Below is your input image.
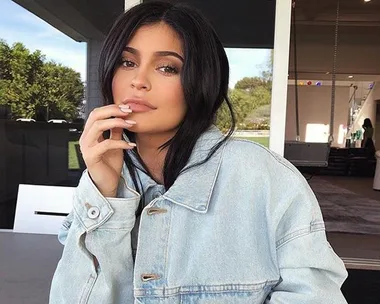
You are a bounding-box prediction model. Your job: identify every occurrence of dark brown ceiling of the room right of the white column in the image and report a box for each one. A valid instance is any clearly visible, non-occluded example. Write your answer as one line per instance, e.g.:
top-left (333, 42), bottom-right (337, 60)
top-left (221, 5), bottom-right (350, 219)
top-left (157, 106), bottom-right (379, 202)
top-left (289, 0), bottom-right (380, 81)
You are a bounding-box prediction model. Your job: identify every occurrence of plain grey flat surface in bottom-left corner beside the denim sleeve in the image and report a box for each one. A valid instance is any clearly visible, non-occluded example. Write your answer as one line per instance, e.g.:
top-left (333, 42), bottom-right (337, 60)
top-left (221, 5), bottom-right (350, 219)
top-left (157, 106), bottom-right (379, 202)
top-left (0, 232), bottom-right (63, 304)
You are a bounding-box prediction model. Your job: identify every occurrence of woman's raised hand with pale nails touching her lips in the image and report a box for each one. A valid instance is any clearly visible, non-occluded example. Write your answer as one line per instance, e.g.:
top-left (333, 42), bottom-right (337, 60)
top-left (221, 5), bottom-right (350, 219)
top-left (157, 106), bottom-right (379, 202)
top-left (79, 104), bottom-right (136, 197)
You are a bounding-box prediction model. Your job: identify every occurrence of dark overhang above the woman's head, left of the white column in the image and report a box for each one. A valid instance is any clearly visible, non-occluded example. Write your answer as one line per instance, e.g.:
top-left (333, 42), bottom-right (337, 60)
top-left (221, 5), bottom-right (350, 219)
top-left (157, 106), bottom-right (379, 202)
top-left (13, 0), bottom-right (276, 48)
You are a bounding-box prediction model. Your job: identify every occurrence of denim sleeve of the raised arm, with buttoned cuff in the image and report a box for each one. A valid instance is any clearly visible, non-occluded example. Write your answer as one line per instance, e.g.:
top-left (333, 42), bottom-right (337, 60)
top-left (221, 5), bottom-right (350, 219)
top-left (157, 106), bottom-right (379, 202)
top-left (49, 171), bottom-right (140, 304)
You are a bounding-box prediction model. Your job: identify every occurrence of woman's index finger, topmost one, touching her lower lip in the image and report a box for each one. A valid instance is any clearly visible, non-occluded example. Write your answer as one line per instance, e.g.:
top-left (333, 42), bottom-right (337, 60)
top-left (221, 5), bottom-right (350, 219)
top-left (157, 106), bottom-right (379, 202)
top-left (83, 104), bottom-right (132, 140)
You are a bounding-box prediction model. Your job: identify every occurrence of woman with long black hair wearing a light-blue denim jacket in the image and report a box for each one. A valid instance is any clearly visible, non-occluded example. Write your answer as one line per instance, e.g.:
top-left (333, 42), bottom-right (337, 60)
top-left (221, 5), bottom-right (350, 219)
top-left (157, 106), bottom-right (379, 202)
top-left (50, 2), bottom-right (346, 304)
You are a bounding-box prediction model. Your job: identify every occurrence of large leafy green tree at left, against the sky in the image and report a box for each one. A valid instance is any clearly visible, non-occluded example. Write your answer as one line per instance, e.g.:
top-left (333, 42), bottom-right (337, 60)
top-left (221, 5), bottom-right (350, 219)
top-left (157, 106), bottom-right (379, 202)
top-left (0, 40), bottom-right (84, 120)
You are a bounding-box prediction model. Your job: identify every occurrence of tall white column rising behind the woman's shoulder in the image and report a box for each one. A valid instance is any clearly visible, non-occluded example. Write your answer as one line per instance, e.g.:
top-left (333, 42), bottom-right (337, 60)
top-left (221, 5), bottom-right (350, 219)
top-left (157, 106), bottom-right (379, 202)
top-left (269, 0), bottom-right (292, 155)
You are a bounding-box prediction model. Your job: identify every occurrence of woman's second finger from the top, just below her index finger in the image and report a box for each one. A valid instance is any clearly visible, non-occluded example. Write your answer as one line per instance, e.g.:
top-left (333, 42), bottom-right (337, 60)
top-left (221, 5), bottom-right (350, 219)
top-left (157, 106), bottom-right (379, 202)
top-left (81, 118), bottom-right (136, 147)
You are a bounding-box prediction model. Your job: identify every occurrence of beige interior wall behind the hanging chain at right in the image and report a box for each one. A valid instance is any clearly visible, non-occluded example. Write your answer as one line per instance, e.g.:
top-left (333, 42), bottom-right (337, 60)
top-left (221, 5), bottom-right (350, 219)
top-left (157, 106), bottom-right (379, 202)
top-left (285, 85), bottom-right (350, 146)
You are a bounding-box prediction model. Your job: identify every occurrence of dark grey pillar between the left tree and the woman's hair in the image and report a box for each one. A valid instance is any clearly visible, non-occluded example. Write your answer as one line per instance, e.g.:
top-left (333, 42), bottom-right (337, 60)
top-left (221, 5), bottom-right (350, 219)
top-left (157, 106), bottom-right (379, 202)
top-left (85, 39), bottom-right (103, 118)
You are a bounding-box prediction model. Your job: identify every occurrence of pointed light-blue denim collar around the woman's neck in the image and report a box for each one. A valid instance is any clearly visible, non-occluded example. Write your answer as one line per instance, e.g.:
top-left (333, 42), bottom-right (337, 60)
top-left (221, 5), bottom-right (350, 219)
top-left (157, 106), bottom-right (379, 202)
top-left (123, 126), bottom-right (225, 213)
